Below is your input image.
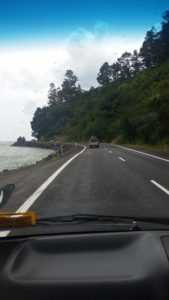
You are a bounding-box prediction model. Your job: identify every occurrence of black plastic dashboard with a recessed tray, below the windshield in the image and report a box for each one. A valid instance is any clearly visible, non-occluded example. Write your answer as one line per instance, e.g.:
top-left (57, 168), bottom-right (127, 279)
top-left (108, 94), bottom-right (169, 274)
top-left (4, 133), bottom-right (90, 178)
top-left (0, 231), bottom-right (169, 300)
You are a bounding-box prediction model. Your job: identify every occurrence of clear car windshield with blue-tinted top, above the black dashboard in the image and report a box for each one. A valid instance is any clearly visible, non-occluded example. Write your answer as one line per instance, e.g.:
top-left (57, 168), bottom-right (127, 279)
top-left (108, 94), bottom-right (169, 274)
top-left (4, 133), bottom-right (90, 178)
top-left (0, 0), bottom-right (169, 237)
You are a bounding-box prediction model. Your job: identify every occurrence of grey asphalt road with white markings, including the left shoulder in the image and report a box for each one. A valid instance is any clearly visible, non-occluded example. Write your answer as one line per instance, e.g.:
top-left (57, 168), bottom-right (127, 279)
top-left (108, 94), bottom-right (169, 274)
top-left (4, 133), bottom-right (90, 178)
top-left (2, 144), bottom-right (169, 224)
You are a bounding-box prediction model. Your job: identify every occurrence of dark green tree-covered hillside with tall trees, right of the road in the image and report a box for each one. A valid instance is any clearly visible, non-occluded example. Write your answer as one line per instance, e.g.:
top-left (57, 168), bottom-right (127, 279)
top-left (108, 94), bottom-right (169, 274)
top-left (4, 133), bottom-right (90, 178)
top-left (31, 11), bottom-right (169, 144)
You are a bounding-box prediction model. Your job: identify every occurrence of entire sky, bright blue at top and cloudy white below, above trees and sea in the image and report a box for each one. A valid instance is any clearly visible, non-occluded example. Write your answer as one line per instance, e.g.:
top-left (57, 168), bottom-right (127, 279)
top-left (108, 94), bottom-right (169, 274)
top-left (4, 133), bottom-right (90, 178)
top-left (0, 0), bottom-right (169, 141)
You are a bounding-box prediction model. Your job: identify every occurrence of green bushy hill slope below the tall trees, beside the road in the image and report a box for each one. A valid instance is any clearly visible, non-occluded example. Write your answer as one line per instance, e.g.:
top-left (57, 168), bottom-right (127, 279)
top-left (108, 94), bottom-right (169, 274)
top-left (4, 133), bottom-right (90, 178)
top-left (62, 62), bottom-right (169, 143)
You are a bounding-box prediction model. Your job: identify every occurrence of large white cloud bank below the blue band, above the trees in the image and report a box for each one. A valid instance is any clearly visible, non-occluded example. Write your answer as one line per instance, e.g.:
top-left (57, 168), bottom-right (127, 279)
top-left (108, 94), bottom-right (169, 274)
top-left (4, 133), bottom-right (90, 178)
top-left (0, 21), bottom-right (143, 140)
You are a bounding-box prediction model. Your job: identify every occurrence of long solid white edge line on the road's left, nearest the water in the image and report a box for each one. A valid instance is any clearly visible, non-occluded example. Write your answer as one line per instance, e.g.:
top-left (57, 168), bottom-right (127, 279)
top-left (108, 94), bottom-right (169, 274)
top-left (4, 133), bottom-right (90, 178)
top-left (0, 145), bottom-right (86, 237)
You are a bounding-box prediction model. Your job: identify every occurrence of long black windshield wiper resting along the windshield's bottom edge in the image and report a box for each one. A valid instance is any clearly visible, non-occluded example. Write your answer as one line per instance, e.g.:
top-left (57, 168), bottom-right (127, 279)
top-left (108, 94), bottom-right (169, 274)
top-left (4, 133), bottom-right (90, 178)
top-left (36, 214), bottom-right (137, 230)
